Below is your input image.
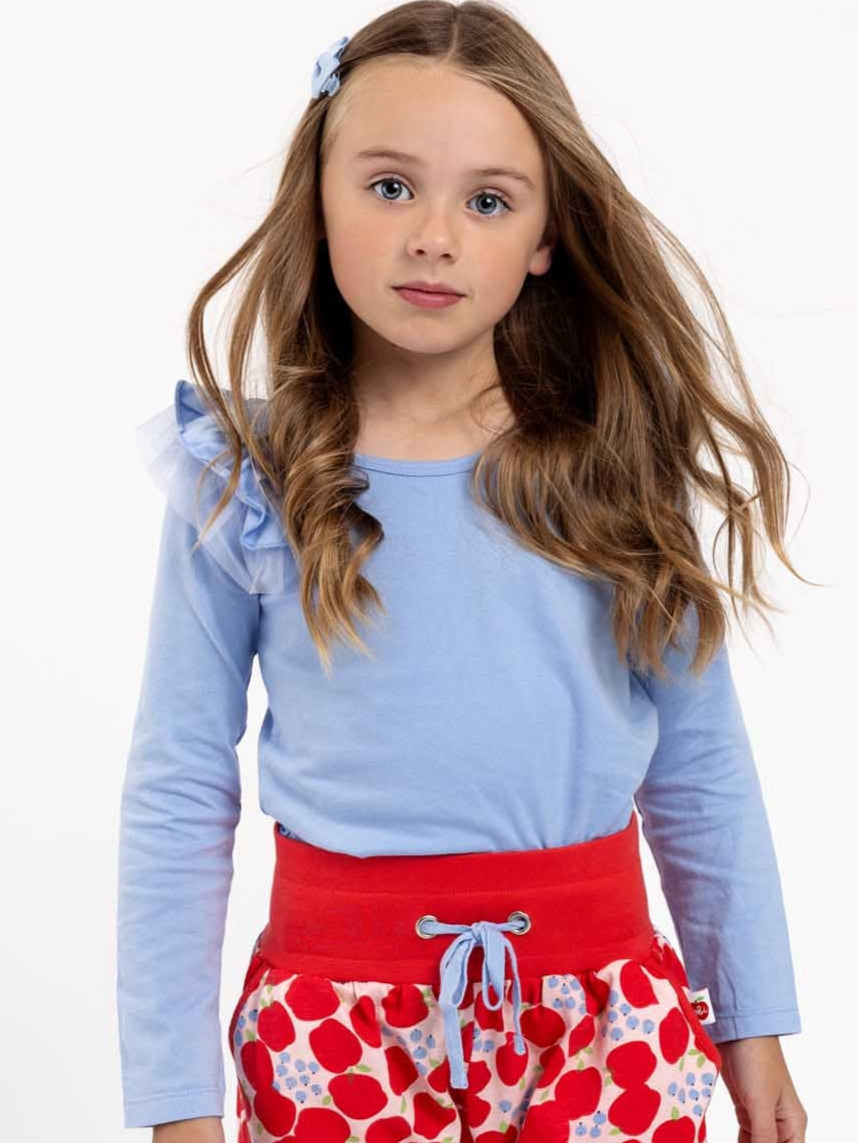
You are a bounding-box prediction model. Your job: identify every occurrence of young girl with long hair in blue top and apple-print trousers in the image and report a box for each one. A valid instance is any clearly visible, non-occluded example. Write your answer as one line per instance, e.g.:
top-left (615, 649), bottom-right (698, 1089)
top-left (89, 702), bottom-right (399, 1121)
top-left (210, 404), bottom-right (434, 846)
top-left (118, 0), bottom-right (807, 1143)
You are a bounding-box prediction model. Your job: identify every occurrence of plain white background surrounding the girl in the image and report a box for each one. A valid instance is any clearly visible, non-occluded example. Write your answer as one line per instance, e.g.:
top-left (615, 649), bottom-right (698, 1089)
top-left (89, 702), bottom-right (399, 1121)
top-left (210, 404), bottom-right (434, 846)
top-left (0, 0), bottom-right (858, 1143)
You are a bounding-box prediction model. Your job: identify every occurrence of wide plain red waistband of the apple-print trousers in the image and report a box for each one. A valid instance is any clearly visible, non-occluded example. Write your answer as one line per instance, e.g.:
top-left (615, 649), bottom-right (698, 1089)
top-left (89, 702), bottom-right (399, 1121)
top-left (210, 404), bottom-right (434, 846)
top-left (255, 810), bottom-right (653, 983)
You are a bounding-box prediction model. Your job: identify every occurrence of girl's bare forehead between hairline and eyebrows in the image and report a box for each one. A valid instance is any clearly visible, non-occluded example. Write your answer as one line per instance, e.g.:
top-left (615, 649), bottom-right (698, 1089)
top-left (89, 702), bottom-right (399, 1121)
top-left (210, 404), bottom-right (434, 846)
top-left (329, 56), bottom-right (540, 182)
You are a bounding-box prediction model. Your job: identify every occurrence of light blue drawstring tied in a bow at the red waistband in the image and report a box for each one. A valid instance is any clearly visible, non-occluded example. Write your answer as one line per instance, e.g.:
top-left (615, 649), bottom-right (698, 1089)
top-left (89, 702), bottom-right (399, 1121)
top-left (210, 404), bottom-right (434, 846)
top-left (420, 919), bottom-right (527, 1088)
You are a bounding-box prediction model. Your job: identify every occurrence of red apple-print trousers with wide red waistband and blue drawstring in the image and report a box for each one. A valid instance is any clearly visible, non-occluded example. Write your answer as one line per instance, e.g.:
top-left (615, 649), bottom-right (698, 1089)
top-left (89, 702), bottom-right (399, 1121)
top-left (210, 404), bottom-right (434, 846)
top-left (228, 812), bottom-right (721, 1143)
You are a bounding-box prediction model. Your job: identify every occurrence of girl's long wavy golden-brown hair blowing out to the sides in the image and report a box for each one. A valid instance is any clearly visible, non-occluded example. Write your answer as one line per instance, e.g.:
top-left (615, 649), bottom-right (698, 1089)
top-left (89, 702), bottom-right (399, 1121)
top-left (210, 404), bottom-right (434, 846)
top-left (181, 0), bottom-right (808, 677)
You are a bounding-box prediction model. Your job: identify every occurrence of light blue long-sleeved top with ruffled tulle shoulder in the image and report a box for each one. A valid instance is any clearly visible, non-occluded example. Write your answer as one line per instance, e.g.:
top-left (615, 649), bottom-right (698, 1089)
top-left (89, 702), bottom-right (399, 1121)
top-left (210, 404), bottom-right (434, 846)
top-left (117, 381), bottom-right (801, 1127)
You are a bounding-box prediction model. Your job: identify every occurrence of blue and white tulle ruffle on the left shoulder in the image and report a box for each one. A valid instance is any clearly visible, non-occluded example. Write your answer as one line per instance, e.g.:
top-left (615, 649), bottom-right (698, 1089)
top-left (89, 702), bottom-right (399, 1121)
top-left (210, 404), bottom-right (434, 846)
top-left (135, 379), bottom-right (295, 593)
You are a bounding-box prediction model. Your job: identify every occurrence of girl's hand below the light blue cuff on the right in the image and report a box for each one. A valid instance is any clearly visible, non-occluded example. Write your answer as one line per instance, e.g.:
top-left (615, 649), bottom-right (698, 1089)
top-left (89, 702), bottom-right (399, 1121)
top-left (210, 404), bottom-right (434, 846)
top-left (717, 1036), bottom-right (808, 1143)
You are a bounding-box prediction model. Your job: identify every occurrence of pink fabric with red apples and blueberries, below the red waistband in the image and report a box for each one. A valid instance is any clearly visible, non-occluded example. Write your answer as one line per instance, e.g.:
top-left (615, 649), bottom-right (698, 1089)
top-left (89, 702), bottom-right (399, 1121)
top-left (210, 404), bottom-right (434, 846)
top-left (228, 929), bottom-right (721, 1143)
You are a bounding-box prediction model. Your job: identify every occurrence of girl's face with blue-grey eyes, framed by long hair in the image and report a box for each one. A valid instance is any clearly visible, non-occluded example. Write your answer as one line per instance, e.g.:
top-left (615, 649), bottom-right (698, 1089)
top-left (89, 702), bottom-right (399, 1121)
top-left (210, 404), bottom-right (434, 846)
top-left (321, 58), bottom-right (551, 353)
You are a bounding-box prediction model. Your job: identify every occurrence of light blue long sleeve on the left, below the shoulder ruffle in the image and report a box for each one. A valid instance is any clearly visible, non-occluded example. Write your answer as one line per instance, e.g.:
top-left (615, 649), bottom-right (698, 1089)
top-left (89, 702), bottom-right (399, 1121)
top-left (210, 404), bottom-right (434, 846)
top-left (117, 502), bottom-right (259, 1127)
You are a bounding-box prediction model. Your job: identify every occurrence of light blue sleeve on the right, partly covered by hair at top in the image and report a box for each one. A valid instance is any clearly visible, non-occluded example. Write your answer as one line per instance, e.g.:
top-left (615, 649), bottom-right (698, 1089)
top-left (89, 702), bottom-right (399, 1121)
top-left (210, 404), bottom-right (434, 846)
top-left (634, 608), bottom-right (802, 1042)
